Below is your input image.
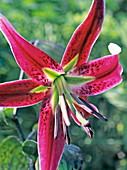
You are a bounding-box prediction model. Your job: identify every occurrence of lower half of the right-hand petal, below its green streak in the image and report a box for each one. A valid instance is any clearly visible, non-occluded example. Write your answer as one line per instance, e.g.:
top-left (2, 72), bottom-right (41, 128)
top-left (70, 57), bottom-right (122, 96)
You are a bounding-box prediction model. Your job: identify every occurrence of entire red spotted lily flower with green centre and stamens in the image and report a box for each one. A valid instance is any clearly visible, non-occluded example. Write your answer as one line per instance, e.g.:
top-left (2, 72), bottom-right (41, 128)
top-left (0, 0), bottom-right (122, 170)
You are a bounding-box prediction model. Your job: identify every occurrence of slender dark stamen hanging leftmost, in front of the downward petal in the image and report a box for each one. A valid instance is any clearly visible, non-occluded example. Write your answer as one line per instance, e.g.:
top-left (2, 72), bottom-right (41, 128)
top-left (54, 105), bottom-right (60, 139)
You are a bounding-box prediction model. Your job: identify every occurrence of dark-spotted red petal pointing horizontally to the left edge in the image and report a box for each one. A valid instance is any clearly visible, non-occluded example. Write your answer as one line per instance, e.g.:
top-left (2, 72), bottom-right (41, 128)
top-left (0, 79), bottom-right (45, 107)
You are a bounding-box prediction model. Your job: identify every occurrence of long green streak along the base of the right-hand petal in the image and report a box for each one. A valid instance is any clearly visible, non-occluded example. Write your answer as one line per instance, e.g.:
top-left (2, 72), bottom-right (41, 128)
top-left (65, 76), bottom-right (95, 85)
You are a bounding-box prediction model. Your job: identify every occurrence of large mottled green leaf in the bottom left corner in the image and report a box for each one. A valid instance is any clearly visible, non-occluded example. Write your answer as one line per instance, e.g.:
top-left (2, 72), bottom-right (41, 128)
top-left (0, 136), bottom-right (29, 170)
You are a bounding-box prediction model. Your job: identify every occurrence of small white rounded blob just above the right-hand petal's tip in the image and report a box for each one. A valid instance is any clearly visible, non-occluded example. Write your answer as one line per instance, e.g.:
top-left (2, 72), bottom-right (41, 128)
top-left (108, 43), bottom-right (121, 55)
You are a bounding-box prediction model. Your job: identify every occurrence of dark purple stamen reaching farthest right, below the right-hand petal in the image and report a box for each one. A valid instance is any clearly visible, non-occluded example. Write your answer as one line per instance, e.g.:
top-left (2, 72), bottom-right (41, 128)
top-left (70, 93), bottom-right (108, 121)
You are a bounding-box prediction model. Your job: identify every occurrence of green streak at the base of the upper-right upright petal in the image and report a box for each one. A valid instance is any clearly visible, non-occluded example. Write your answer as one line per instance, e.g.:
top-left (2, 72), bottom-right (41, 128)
top-left (63, 54), bottom-right (79, 73)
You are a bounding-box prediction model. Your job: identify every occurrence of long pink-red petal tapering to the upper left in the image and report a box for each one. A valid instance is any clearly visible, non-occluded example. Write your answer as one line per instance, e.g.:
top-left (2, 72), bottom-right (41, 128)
top-left (0, 14), bottom-right (63, 86)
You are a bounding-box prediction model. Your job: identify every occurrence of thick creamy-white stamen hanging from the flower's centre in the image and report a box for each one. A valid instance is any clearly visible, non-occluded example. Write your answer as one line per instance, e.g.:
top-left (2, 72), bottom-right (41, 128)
top-left (59, 94), bottom-right (71, 126)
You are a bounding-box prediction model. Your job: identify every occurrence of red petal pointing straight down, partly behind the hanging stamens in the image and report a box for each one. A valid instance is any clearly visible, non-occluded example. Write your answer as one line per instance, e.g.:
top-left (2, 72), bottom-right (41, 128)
top-left (38, 89), bottom-right (65, 170)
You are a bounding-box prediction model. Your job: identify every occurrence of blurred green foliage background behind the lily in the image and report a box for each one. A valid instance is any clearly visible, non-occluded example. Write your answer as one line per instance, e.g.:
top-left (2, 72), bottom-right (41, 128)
top-left (0, 0), bottom-right (127, 170)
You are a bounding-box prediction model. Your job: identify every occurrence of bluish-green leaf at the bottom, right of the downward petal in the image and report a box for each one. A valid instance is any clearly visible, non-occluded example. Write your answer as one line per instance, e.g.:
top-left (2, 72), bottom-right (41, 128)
top-left (58, 145), bottom-right (84, 170)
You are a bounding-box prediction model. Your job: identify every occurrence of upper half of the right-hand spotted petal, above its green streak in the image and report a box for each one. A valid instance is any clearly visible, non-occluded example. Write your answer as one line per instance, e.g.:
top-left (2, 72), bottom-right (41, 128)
top-left (69, 55), bottom-right (119, 78)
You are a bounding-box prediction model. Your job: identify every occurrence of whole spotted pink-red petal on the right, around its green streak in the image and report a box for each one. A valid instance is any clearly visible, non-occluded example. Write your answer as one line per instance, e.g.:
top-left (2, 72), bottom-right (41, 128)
top-left (70, 55), bottom-right (122, 96)
